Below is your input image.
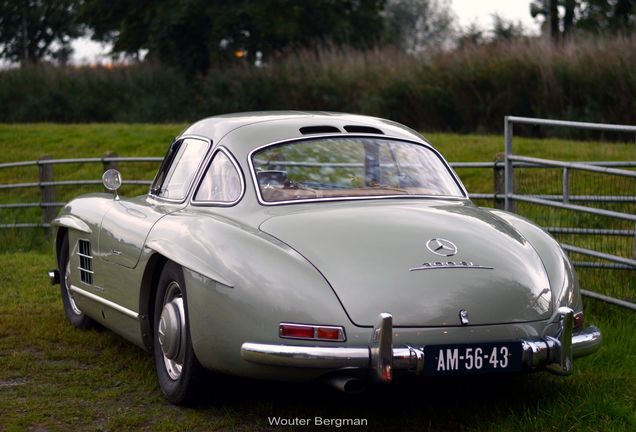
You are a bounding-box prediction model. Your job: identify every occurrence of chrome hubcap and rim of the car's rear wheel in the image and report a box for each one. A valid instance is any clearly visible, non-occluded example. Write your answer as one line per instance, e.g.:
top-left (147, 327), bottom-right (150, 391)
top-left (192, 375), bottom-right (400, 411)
top-left (157, 282), bottom-right (186, 380)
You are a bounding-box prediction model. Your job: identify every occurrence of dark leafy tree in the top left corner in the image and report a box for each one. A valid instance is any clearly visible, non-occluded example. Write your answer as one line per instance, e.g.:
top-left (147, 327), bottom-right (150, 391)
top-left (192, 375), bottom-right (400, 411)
top-left (0, 0), bottom-right (82, 65)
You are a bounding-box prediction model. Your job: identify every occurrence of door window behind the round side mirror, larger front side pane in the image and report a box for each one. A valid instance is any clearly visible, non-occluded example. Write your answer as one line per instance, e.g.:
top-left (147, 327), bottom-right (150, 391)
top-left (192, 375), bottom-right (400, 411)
top-left (153, 138), bottom-right (208, 200)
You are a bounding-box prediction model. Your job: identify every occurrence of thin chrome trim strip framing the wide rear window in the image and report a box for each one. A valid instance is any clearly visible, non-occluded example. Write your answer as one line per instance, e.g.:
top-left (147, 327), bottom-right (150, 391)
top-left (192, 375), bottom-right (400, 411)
top-left (247, 134), bottom-right (470, 206)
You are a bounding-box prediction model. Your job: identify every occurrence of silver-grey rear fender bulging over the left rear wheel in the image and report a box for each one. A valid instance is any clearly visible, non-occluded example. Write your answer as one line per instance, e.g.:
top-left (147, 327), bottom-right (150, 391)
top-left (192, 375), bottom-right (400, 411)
top-left (146, 212), bottom-right (353, 374)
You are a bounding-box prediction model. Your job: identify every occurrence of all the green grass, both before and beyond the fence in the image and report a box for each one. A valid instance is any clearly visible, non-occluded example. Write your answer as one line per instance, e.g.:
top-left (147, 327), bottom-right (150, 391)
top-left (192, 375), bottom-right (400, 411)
top-left (0, 125), bottom-right (636, 431)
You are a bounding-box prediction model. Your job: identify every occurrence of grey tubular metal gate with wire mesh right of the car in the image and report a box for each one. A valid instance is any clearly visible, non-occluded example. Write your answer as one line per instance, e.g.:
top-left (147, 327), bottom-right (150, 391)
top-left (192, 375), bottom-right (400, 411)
top-left (504, 117), bottom-right (636, 310)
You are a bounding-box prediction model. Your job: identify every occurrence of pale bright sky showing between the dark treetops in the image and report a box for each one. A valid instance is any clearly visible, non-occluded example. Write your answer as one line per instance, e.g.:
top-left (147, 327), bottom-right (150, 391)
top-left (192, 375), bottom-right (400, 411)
top-left (67, 0), bottom-right (540, 64)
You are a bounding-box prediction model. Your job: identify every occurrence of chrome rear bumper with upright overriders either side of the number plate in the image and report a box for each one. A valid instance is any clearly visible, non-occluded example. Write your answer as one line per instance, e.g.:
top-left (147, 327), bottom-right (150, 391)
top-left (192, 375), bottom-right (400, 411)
top-left (241, 307), bottom-right (601, 382)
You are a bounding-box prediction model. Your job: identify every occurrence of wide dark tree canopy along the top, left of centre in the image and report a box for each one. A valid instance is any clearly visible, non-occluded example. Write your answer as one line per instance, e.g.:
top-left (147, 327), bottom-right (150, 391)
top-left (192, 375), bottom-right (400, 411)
top-left (81, 0), bottom-right (384, 75)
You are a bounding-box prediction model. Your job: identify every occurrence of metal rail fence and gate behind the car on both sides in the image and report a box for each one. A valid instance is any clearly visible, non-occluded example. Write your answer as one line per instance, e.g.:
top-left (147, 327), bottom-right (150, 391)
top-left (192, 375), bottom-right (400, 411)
top-left (0, 121), bottom-right (636, 310)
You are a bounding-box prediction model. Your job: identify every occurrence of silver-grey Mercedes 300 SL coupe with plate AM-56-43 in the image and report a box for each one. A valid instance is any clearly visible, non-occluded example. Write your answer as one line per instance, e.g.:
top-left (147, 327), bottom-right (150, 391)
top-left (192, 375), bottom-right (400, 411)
top-left (50, 112), bottom-right (601, 403)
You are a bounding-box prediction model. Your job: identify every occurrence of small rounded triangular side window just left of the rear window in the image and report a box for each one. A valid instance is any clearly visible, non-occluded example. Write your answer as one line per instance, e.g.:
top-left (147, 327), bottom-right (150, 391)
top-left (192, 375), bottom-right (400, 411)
top-left (194, 151), bottom-right (242, 203)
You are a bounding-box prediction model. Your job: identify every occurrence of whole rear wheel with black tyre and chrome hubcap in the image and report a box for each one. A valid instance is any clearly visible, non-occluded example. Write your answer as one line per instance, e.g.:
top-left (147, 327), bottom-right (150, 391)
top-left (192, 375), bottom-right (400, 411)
top-left (153, 262), bottom-right (203, 405)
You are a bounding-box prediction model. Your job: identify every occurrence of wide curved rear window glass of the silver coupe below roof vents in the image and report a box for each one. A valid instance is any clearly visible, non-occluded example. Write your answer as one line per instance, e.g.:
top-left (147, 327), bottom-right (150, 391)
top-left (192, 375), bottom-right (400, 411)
top-left (251, 137), bottom-right (464, 203)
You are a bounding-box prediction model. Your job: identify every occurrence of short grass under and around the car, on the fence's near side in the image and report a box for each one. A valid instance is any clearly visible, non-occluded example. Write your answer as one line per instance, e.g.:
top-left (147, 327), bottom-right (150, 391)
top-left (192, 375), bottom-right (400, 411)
top-left (0, 253), bottom-right (636, 431)
